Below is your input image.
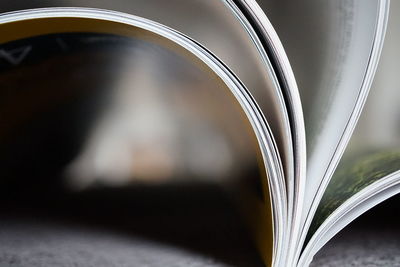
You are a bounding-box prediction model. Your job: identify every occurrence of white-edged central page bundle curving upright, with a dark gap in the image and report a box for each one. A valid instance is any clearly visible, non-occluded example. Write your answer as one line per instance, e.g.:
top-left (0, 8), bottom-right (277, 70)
top-left (227, 0), bottom-right (306, 265)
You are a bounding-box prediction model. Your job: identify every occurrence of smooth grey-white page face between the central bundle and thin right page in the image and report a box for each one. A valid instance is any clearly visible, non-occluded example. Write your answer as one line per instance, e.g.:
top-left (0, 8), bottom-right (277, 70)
top-left (259, 0), bottom-right (379, 216)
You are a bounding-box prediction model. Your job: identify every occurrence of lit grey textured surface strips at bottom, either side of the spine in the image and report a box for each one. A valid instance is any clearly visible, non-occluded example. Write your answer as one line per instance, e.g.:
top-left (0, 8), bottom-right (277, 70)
top-left (0, 219), bottom-right (400, 267)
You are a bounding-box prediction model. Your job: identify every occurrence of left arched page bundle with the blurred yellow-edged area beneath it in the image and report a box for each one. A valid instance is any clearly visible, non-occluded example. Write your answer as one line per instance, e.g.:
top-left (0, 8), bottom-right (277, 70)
top-left (0, 9), bottom-right (283, 263)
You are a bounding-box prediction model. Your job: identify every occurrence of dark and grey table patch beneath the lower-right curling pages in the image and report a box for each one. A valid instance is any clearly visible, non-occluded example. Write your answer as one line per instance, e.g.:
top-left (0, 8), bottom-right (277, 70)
top-left (311, 196), bottom-right (400, 267)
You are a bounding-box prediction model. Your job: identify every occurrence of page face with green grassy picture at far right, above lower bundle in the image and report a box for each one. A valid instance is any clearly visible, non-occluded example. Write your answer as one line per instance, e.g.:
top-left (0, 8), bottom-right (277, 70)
top-left (309, 3), bottom-right (400, 237)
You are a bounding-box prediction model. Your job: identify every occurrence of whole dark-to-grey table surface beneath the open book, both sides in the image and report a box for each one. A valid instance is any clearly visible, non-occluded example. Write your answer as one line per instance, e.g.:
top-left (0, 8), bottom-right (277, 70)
top-left (0, 185), bottom-right (400, 267)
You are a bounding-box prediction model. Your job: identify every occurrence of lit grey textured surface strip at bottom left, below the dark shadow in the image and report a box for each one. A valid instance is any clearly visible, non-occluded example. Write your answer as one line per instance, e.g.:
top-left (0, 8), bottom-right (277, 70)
top-left (0, 221), bottom-right (228, 267)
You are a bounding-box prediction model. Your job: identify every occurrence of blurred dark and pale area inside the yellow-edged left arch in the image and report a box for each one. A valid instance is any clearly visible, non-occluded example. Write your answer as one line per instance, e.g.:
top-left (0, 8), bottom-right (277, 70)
top-left (0, 33), bottom-right (257, 190)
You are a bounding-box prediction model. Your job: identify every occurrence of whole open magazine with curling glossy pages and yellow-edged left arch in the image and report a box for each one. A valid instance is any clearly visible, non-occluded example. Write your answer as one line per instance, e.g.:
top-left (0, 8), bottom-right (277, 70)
top-left (0, 0), bottom-right (400, 266)
